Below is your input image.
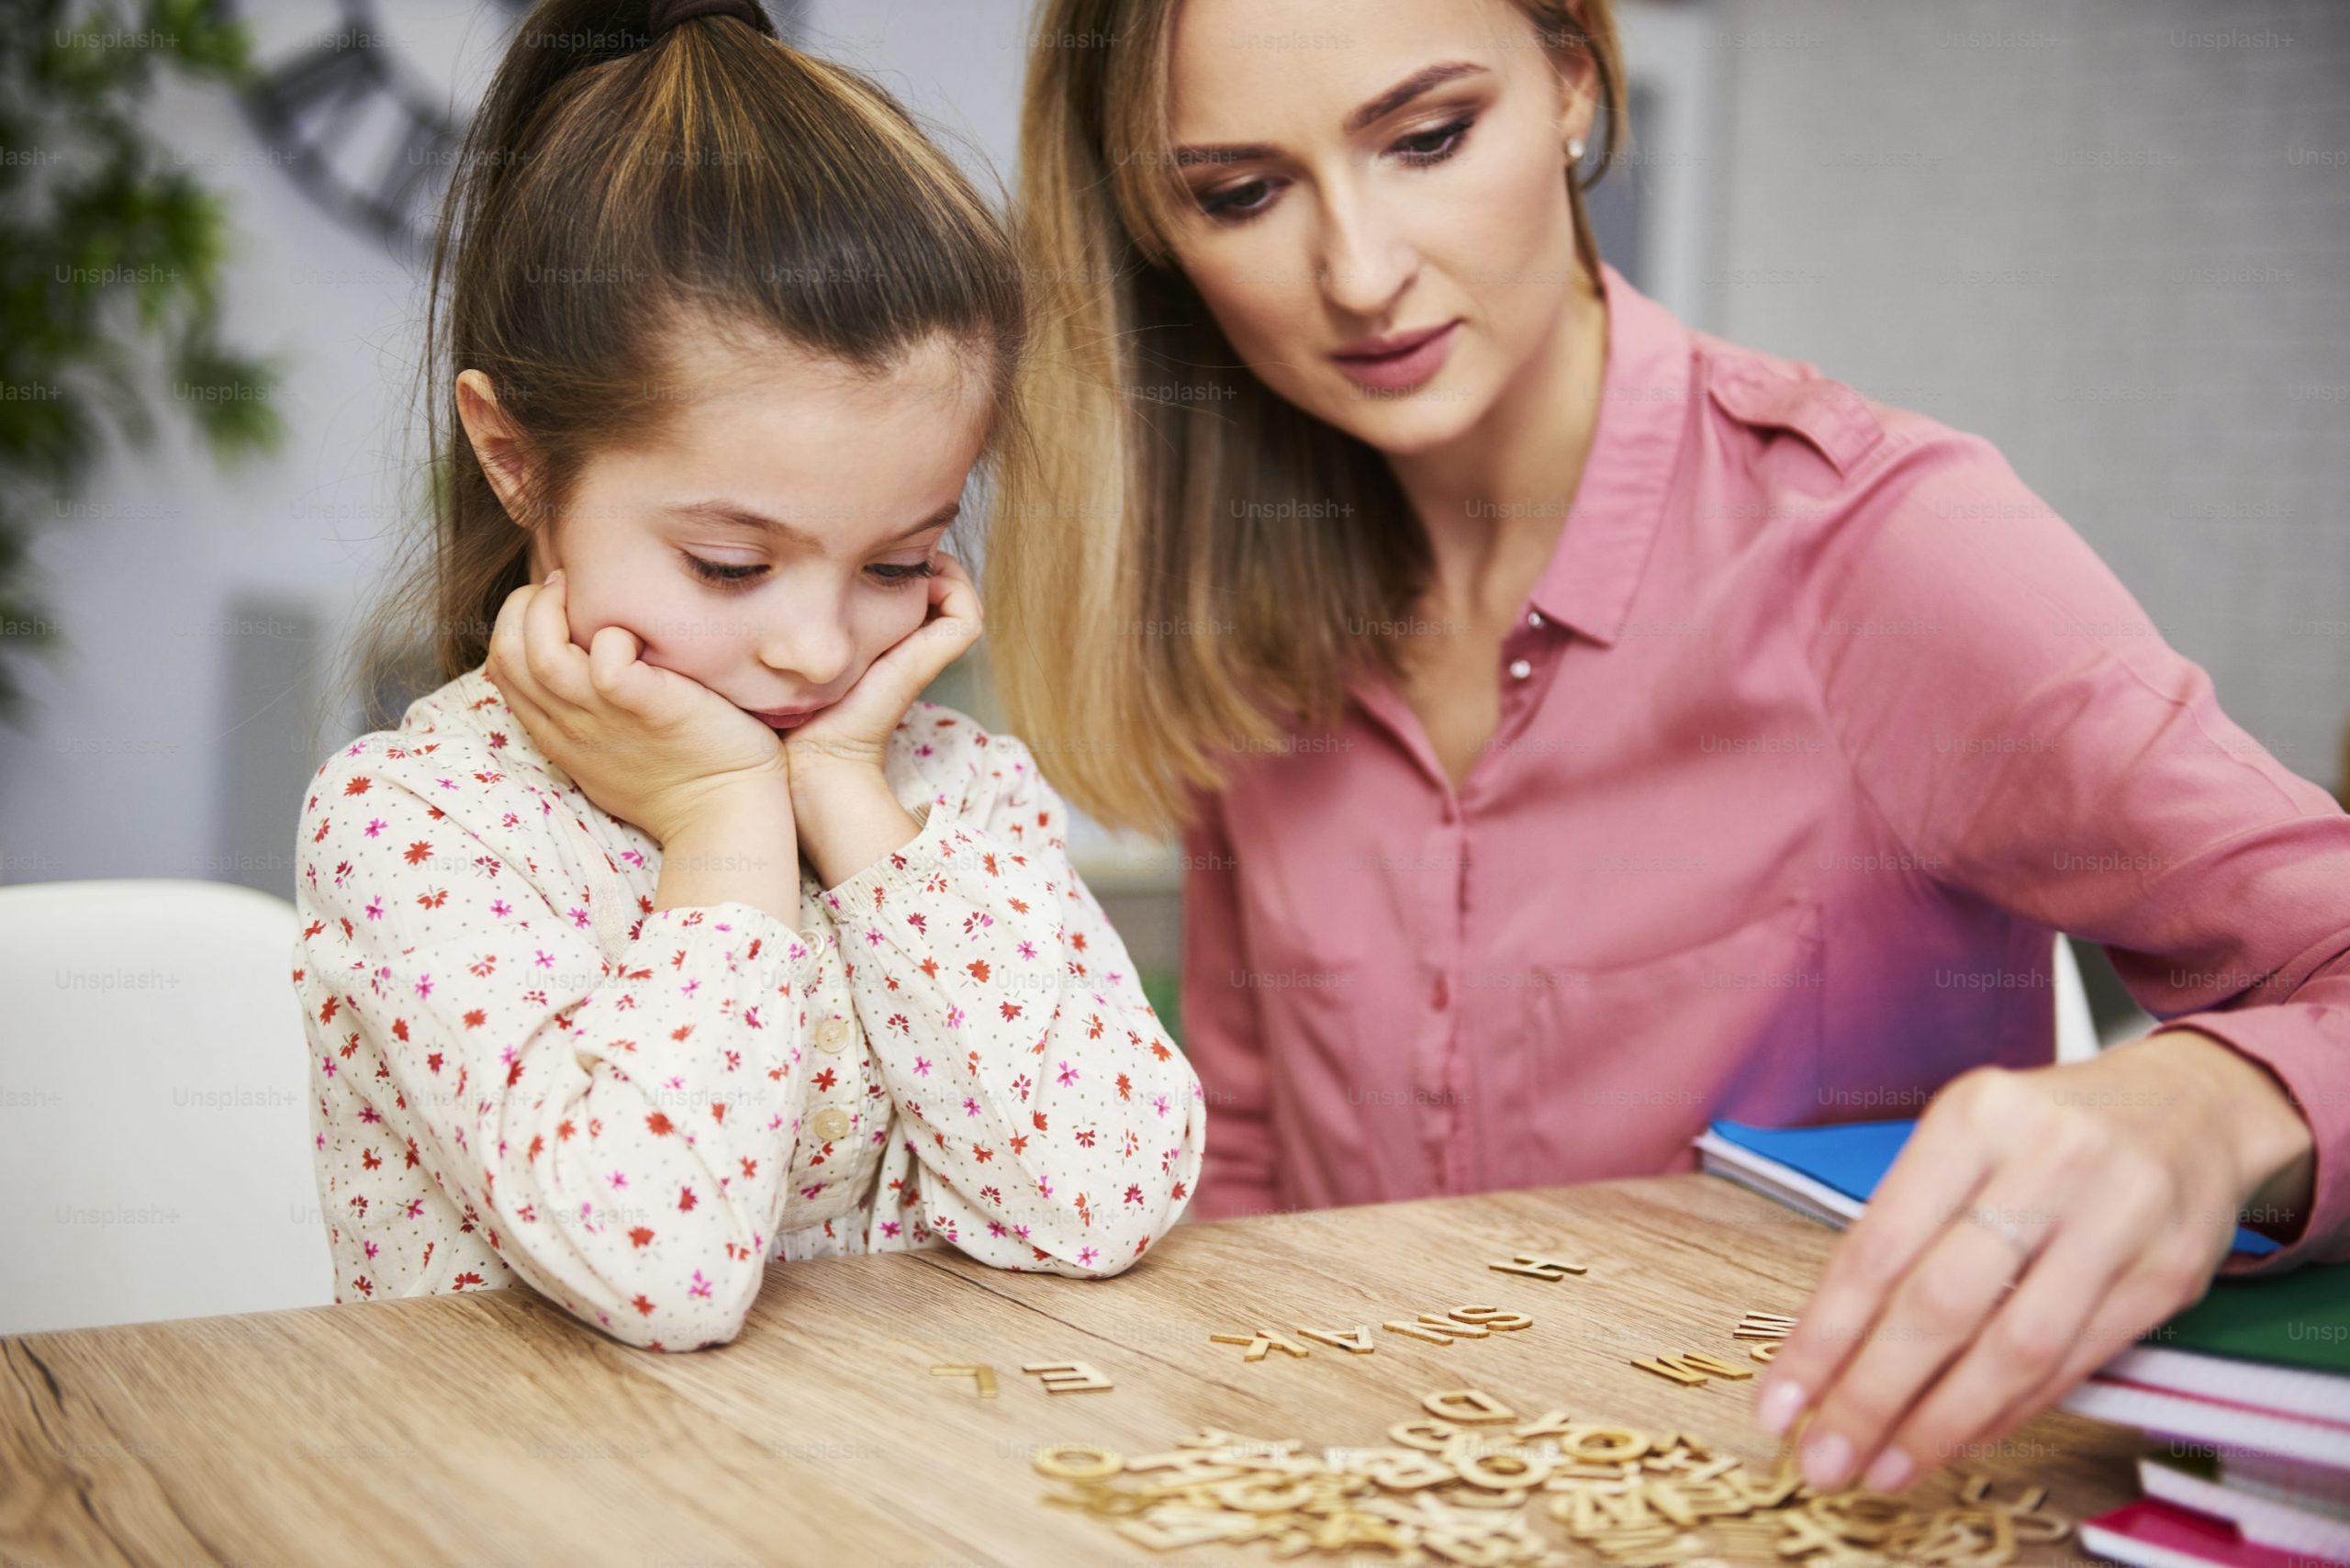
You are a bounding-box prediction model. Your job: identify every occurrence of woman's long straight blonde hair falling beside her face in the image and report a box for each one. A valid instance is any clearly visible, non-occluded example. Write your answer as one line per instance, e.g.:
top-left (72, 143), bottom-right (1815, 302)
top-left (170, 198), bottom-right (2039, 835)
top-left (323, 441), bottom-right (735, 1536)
top-left (987, 0), bottom-right (1624, 832)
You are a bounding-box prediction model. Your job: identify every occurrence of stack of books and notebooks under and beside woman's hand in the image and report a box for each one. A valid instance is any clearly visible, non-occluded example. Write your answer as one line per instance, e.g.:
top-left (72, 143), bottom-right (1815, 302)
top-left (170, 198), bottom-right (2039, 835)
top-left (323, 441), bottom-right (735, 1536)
top-left (1696, 1121), bottom-right (2350, 1568)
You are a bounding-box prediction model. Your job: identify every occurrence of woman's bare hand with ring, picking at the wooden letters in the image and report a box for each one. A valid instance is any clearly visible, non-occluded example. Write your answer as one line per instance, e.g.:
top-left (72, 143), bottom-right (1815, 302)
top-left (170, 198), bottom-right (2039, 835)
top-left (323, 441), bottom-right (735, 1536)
top-left (1755, 1030), bottom-right (2312, 1490)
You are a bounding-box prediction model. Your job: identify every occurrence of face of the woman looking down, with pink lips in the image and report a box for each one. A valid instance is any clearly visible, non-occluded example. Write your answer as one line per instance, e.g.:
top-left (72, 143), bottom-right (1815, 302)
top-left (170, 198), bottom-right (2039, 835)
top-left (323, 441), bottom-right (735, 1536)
top-left (1170, 0), bottom-right (1591, 456)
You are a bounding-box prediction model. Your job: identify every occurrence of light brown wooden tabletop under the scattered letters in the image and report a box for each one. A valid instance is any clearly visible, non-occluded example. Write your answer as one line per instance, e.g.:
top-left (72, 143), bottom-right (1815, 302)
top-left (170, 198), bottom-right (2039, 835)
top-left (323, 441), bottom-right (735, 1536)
top-left (0, 1175), bottom-right (2145, 1568)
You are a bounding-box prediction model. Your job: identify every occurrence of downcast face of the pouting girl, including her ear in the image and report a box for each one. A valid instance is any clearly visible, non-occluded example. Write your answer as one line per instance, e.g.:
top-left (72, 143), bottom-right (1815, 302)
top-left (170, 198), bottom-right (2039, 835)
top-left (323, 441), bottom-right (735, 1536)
top-left (458, 331), bottom-right (991, 729)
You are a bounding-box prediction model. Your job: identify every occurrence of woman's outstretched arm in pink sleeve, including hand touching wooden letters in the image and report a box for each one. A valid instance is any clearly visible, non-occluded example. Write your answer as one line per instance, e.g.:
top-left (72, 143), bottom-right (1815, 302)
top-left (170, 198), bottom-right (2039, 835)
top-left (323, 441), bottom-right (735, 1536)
top-left (1760, 416), bottom-right (2350, 1485)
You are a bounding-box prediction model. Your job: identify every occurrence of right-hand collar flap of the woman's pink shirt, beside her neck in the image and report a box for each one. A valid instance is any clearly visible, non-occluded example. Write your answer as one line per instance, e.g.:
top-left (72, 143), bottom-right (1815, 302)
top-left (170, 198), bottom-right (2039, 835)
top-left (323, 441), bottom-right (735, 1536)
top-left (1528, 261), bottom-right (1695, 644)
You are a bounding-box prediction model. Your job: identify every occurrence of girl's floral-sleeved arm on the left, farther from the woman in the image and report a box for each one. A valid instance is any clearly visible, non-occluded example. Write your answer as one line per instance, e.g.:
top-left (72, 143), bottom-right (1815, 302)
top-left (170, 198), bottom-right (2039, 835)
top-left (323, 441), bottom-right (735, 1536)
top-left (297, 741), bottom-right (815, 1350)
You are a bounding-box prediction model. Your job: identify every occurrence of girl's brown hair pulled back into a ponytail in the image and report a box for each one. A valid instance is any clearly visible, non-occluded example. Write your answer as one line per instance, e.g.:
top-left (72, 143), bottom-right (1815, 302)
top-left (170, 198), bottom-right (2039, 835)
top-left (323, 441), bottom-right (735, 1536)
top-left (329, 0), bottom-right (1027, 724)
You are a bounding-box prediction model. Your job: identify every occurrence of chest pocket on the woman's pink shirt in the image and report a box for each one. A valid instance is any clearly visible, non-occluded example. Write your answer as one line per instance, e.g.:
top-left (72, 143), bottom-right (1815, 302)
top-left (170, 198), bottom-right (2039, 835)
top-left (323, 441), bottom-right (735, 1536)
top-left (1481, 898), bottom-right (1826, 1187)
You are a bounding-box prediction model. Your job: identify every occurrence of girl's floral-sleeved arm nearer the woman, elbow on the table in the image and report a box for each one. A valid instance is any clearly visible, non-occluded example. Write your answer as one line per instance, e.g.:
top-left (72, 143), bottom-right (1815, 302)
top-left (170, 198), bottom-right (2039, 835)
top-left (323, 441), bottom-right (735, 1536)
top-left (801, 705), bottom-right (1205, 1274)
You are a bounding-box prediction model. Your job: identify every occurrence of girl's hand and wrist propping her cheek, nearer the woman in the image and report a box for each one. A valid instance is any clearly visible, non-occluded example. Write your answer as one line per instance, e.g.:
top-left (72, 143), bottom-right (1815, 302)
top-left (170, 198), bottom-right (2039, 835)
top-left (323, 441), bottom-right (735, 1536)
top-left (782, 553), bottom-right (980, 889)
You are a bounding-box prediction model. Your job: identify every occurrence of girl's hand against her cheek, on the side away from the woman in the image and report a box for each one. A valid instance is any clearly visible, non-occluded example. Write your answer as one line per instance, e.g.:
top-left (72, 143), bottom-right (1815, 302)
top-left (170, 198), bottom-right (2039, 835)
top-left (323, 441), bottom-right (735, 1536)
top-left (487, 571), bottom-right (789, 844)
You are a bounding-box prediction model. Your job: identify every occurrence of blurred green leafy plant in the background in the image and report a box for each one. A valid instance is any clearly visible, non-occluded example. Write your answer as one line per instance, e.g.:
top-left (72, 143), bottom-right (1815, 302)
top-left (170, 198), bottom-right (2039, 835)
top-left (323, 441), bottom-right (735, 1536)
top-left (0, 0), bottom-right (282, 720)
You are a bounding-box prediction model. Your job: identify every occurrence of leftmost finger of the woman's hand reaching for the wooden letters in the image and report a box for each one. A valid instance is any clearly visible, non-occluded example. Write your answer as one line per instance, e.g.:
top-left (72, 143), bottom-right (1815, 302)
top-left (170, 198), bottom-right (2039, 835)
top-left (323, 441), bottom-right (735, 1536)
top-left (1755, 1074), bottom-right (2007, 1448)
